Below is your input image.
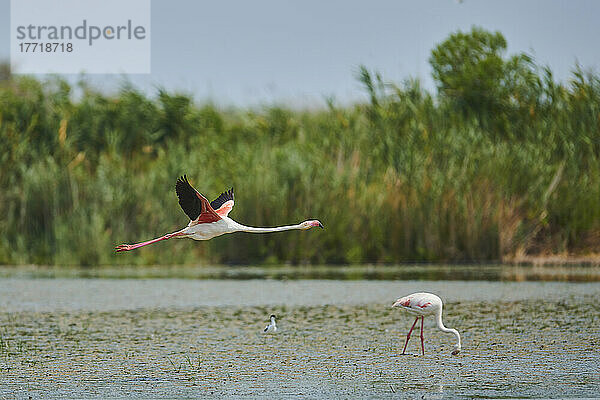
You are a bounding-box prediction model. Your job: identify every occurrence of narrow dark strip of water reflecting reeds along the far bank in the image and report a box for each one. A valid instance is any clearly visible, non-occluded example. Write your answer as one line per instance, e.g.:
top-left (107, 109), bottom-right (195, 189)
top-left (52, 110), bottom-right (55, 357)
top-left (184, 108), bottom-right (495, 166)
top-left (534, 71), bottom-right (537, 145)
top-left (0, 264), bottom-right (600, 282)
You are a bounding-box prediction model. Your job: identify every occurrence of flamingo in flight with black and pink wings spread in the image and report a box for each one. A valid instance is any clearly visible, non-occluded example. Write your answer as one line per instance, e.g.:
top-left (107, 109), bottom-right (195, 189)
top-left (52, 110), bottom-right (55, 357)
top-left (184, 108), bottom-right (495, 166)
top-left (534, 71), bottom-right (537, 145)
top-left (115, 175), bottom-right (323, 252)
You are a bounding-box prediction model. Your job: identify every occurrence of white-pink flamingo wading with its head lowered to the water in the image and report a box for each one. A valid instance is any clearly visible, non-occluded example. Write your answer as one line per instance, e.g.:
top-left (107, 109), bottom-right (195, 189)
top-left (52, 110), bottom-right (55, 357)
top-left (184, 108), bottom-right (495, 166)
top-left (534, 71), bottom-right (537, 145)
top-left (392, 293), bottom-right (461, 356)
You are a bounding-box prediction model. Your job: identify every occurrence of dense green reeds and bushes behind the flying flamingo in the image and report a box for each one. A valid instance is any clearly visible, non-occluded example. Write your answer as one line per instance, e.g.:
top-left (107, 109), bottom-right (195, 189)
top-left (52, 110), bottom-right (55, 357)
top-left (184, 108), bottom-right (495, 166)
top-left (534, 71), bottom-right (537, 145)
top-left (0, 28), bottom-right (600, 265)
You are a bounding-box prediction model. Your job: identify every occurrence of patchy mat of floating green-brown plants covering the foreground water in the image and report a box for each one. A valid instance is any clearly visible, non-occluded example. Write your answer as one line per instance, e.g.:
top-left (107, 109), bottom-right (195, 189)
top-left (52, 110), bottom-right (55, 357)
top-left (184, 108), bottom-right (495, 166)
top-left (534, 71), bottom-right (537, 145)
top-left (0, 282), bottom-right (600, 398)
